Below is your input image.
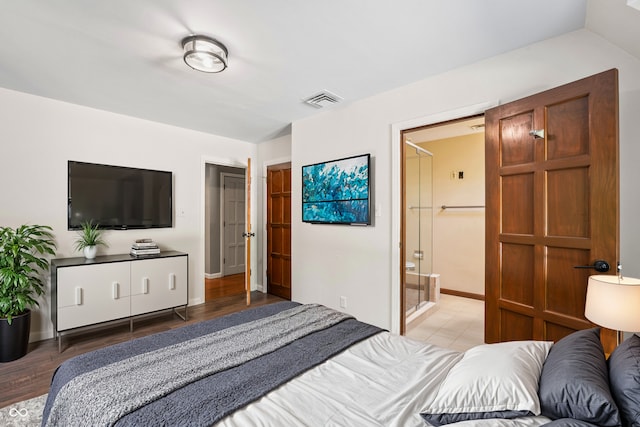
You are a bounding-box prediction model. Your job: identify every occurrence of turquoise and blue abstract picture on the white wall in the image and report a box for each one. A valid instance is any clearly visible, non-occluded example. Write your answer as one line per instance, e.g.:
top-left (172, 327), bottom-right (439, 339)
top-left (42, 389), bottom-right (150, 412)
top-left (302, 154), bottom-right (371, 225)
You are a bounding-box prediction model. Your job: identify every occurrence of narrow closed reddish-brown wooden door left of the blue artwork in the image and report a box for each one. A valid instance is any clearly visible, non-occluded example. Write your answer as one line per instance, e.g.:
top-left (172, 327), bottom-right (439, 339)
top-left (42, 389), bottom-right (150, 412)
top-left (267, 163), bottom-right (291, 299)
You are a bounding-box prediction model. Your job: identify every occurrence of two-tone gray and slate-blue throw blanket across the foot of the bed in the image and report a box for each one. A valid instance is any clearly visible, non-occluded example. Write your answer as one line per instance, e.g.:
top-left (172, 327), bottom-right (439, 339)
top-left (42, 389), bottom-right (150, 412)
top-left (43, 303), bottom-right (380, 426)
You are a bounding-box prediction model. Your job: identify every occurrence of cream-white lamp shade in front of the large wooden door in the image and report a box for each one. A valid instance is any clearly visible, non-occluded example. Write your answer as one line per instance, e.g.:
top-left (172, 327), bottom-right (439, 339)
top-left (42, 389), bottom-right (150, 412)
top-left (584, 275), bottom-right (640, 332)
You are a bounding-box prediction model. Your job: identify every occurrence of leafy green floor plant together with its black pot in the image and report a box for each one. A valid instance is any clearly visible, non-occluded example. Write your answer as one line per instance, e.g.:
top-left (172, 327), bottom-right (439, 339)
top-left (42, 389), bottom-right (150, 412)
top-left (0, 225), bottom-right (56, 362)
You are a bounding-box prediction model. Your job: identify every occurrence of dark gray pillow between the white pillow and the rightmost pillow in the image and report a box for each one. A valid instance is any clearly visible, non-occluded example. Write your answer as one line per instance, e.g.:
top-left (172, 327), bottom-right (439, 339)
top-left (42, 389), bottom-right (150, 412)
top-left (538, 328), bottom-right (620, 427)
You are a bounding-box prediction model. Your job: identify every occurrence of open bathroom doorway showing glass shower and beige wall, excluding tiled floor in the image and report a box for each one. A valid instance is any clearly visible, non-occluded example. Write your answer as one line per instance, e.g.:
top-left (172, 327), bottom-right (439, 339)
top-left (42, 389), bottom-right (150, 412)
top-left (400, 116), bottom-right (485, 332)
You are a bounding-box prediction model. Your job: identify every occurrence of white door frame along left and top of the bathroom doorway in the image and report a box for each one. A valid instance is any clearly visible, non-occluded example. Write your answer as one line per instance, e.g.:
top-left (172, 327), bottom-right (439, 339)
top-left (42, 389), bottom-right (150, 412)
top-left (391, 101), bottom-right (499, 334)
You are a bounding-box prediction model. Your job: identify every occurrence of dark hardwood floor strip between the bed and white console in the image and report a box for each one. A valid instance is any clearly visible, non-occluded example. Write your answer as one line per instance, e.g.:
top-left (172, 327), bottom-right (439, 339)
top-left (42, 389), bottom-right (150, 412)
top-left (0, 292), bottom-right (284, 408)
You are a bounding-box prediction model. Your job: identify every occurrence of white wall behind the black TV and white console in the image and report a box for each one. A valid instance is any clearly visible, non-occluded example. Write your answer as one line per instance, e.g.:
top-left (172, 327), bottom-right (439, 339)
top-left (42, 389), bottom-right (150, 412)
top-left (0, 89), bottom-right (257, 341)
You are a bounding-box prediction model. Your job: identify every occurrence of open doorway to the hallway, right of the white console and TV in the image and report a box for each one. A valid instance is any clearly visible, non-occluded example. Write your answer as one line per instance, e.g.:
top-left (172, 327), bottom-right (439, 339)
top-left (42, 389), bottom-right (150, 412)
top-left (204, 163), bottom-right (246, 301)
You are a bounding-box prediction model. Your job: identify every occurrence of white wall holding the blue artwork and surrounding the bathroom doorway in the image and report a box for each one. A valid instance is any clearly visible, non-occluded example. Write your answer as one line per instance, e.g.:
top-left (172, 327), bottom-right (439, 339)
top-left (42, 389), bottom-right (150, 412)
top-left (291, 30), bottom-right (640, 331)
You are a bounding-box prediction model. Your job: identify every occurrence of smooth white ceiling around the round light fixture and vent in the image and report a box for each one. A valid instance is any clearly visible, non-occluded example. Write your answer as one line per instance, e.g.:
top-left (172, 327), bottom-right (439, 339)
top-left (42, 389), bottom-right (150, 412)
top-left (0, 0), bottom-right (640, 142)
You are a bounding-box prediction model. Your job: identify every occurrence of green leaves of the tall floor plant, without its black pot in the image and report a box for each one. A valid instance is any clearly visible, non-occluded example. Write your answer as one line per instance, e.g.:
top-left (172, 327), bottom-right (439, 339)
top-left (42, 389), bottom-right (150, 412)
top-left (0, 225), bottom-right (56, 324)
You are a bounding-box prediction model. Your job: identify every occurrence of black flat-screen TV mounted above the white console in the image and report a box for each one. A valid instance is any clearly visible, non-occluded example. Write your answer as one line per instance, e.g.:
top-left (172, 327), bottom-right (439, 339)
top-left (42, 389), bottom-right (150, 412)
top-left (68, 161), bottom-right (173, 230)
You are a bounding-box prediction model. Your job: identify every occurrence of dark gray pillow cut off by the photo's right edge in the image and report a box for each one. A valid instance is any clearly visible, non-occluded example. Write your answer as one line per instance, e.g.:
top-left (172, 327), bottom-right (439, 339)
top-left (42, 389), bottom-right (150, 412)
top-left (608, 335), bottom-right (640, 427)
